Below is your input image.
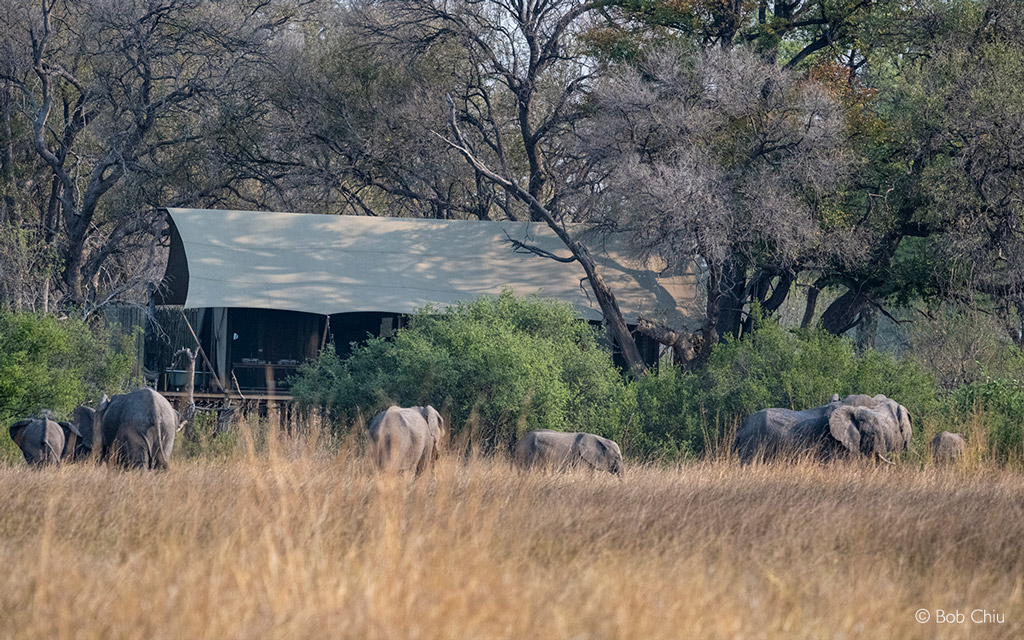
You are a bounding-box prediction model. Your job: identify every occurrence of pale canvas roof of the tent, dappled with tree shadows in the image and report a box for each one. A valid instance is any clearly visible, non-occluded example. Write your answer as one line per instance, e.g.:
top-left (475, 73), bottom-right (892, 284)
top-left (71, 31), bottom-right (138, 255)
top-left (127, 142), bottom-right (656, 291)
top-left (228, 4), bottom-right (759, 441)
top-left (159, 209), bottom-right (696, 326)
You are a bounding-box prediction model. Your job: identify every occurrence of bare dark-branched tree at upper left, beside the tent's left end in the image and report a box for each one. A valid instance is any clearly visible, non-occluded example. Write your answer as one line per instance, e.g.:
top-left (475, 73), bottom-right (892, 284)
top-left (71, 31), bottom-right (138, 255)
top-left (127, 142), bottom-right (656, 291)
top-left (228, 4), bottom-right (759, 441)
top-left (0, 0), bottom-right (303, 307)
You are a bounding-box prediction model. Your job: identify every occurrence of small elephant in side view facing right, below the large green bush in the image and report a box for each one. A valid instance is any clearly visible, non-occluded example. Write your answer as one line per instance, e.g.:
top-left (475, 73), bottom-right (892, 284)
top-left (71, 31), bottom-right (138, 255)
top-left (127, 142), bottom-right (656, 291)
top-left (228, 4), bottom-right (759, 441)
top-left (513, 429), bottom-right (623, 475)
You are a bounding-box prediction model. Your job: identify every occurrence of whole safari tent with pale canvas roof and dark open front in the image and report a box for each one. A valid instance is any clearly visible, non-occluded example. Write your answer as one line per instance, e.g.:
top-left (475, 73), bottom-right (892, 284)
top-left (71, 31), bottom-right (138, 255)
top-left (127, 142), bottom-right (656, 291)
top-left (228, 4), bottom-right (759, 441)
top-left (143, 209), bottom-right (698, 403)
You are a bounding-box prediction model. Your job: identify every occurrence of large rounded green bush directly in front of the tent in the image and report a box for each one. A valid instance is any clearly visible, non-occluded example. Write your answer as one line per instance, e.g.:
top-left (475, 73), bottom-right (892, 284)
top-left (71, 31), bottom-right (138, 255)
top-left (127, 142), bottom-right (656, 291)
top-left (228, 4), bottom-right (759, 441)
top-left (293, 292), bottom-right (634, 449)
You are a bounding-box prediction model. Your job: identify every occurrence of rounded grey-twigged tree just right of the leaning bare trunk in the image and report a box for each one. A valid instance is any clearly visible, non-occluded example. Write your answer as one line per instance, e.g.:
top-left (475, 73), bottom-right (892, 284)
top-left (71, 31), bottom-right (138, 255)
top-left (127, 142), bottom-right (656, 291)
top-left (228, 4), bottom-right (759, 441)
top-left (585, 49), bottom-right (847, 364)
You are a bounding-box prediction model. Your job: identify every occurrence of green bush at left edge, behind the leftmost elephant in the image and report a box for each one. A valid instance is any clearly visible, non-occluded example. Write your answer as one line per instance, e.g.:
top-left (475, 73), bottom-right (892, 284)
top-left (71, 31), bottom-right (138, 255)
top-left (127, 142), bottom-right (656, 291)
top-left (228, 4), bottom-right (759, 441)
top-left (0, 311), bottom-right (134, 458)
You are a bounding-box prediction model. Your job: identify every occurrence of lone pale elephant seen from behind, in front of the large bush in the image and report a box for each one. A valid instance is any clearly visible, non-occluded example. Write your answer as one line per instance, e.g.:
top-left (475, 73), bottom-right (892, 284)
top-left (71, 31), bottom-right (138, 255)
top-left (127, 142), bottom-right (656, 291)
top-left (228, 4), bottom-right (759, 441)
top-left (370, 406), bottom-right (445, 475)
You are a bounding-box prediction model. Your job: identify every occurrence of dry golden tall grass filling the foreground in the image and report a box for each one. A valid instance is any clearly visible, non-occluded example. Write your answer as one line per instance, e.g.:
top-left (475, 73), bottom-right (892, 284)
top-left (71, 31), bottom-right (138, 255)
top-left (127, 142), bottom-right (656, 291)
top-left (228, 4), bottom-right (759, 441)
top-left (0, 430), bottom-right (1024, 639)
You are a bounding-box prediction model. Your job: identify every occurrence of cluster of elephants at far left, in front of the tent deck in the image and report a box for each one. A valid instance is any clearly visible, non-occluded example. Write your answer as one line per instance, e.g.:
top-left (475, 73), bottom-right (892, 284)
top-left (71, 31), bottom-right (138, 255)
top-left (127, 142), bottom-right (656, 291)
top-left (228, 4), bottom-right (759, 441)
top-left (10, 388), bottom-right (187, 469)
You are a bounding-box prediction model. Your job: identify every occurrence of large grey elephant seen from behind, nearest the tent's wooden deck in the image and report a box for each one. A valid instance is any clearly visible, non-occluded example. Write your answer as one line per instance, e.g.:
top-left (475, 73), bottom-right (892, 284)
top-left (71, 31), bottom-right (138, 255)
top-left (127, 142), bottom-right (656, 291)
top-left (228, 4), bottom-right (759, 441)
top-left (96, 388), bottom-right (187, 470)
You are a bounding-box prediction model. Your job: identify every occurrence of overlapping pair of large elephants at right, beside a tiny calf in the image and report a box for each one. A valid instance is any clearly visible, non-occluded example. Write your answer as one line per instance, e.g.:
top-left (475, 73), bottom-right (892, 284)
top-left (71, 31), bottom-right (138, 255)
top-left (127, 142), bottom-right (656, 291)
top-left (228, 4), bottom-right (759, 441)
top-left (733, 394), bottom-right (913, 463)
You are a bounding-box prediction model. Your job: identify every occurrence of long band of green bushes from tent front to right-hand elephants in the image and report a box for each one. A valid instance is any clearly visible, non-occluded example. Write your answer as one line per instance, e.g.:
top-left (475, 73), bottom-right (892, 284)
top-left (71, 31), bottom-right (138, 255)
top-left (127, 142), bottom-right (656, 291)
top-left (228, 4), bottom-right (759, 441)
top-left (293, 293), bottom-right (938, 460)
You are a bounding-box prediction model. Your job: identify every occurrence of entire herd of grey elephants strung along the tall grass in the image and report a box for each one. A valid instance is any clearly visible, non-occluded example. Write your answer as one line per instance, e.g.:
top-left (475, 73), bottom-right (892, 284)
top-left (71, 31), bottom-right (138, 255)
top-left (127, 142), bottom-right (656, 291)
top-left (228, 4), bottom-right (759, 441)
top-left (10, 388), bottom-right (966, 475)
